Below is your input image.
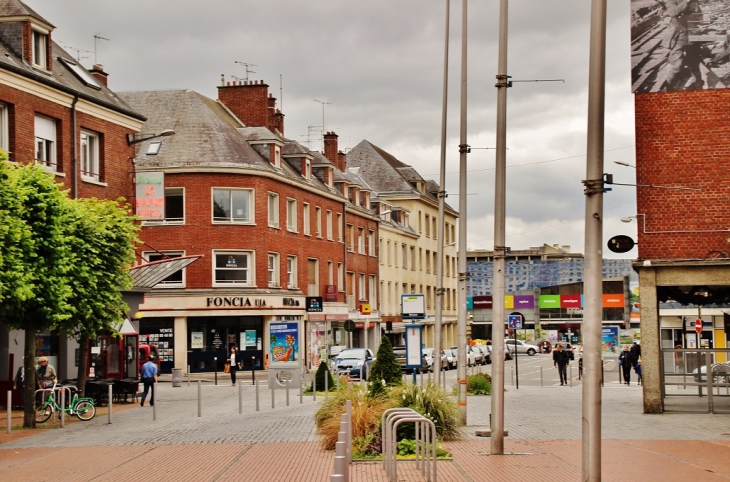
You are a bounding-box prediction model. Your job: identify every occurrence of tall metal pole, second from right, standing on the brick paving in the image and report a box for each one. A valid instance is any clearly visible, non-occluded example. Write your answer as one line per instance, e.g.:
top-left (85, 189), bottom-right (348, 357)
top-left (490, 0), bottom-right (509, 455)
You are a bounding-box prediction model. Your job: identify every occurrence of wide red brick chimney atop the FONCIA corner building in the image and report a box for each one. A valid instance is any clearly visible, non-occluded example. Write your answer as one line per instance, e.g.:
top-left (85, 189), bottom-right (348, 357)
top-left (218, 80), bottom-right (272, 130)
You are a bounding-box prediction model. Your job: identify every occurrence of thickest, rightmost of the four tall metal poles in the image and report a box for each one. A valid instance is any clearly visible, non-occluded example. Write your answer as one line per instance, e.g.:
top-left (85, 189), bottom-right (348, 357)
top-left (582, 0), bottom-right (607, 482)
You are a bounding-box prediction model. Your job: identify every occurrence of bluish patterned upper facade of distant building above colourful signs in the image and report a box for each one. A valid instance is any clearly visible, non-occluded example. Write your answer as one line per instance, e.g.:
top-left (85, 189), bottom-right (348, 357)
top-left (466, 258), bottom-right (636, 296)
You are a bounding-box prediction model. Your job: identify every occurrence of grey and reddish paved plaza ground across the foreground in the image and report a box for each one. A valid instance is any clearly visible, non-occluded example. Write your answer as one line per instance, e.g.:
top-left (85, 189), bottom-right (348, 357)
top-left (0, 374), bottom-right (730, 482)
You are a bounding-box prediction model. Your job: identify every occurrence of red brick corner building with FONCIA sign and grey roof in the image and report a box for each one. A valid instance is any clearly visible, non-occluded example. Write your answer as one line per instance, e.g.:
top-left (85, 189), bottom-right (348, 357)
top-left (120, 81), bottom-right (379, 372)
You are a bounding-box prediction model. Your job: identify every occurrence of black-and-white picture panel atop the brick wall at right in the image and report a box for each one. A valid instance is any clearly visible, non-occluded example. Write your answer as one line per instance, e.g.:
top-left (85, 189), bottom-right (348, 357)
top-left (631, 0), bottom-right (730, 93)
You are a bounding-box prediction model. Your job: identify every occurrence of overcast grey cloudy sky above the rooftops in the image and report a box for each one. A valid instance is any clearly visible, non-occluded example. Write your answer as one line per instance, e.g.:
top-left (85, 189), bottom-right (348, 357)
top-left (31, 0), bottom-right (636, 257)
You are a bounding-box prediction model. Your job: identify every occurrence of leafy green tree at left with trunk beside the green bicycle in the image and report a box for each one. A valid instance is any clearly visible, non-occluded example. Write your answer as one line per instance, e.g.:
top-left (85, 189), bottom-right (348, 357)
top-left (0, 162), bottom-right (136, 427)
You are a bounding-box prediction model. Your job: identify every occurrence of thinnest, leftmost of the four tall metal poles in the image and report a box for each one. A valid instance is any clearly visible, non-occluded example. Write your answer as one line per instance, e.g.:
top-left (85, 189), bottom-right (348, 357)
top-left (433, 0), bottom-right (451, 396)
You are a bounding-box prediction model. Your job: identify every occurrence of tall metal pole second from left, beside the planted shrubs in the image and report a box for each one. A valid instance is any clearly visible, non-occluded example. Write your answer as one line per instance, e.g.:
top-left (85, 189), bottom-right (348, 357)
top-left (456, 0), bottom-right (469, 425)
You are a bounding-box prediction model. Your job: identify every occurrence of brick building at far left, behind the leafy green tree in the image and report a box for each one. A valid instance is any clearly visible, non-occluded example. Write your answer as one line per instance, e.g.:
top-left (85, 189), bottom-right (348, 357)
top-left (0, 0), bottom-right (144, 384)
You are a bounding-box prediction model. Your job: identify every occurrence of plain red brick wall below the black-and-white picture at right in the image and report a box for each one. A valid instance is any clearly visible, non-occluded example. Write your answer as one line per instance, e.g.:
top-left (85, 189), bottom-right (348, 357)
top-left (635, 89), bottom-right (730, 259)
